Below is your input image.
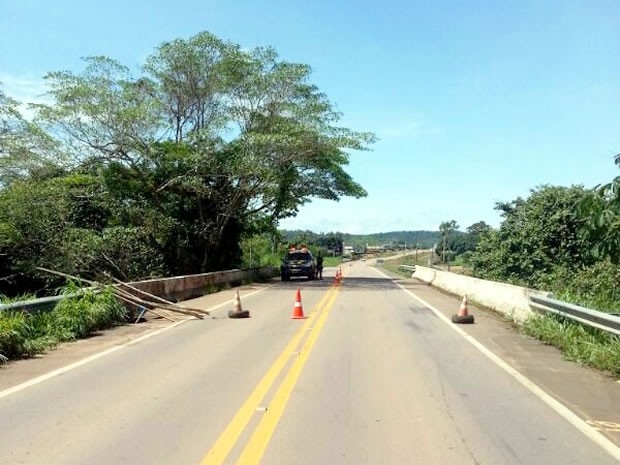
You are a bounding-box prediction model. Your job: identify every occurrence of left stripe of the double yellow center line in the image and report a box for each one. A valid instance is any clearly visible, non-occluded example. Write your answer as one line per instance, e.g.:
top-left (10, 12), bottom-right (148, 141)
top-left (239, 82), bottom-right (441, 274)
top-left (200, 288), bottom-right (335, 465)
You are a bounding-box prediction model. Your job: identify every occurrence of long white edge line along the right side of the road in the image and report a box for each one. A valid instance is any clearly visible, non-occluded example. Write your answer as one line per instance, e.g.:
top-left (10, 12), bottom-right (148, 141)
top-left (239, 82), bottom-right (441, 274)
top-left (374, 268), bottom-right (620, 460)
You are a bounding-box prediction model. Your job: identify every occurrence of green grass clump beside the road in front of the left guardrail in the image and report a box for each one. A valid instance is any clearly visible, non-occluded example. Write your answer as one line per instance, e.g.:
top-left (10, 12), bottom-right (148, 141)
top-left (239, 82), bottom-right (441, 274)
top-left (0, 285), bottom-right (127, 362)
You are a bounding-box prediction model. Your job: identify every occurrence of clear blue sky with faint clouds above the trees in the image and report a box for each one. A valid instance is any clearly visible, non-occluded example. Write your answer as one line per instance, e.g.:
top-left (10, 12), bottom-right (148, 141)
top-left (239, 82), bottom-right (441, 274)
top-left (0, 0), bottom-right (620, 233)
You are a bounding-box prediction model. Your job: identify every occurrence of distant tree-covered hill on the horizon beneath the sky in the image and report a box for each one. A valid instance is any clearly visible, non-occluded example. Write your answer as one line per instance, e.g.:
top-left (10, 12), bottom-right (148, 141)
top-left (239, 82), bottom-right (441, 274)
top-left (280, 230), bottom-right (439, 249)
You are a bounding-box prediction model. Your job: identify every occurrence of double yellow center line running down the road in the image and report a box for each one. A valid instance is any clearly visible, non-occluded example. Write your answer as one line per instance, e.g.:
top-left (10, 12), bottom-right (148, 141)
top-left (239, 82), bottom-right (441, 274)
top-left (200, 287), bottom-right (339, 465)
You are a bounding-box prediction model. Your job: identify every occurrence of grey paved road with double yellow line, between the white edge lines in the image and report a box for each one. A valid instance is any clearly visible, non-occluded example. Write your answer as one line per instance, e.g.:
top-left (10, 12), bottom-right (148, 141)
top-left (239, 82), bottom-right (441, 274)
top-left (0, 263), bottom-right (618, 465)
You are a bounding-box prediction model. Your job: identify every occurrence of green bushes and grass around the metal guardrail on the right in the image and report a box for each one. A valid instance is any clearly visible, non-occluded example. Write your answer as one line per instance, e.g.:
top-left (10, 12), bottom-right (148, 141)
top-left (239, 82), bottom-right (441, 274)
top-left (438, 165), bottom-right (620, 375)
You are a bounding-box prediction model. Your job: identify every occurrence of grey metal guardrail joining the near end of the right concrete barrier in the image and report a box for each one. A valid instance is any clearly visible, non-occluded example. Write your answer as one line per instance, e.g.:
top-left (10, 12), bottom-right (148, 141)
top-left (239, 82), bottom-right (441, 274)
top-left (530, 295), bottom-right (620, 336)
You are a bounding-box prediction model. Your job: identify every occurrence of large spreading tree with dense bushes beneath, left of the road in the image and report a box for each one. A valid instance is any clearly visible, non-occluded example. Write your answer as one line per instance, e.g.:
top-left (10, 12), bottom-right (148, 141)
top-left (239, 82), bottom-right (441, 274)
top-left (0, 32), bottom-right (375, 296)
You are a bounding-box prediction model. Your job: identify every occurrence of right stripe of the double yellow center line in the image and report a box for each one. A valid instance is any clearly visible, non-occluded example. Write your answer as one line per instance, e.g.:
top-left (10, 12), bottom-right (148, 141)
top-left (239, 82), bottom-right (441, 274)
top-left (237, 292), bottom-right (337, 465)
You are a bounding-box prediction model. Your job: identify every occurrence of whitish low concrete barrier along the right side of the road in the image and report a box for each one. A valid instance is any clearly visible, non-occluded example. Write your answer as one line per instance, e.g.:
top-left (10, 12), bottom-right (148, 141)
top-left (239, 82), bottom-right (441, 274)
top-left (411, 265), bottom-right (552, 324)
